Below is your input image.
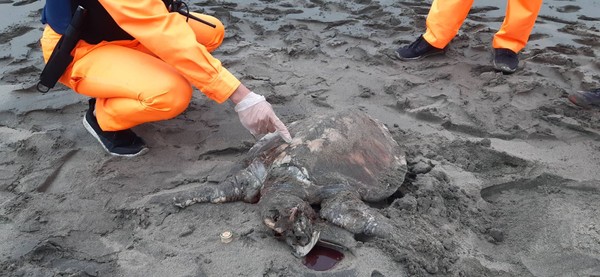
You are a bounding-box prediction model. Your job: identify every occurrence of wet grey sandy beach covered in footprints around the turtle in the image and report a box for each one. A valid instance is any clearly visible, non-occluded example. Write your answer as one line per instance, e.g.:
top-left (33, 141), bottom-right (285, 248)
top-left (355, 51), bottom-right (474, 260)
top-left (0, 0), bottom-right (600, 277)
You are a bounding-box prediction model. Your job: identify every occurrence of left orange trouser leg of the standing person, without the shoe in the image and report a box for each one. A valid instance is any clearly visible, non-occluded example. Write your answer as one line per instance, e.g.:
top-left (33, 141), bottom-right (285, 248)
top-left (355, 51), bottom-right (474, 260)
top-left (423, 0), bottom-right (473, 48)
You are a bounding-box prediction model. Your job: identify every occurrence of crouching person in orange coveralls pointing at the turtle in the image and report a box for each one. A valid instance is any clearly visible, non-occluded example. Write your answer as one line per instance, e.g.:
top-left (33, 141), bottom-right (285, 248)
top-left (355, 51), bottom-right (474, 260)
top-left (40, 0), bottom-right (291, 157)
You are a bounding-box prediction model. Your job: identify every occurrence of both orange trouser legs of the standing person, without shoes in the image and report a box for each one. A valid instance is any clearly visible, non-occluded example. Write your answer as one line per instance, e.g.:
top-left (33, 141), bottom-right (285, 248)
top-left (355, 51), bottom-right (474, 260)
top-left (423, 0), bottom-right (542, 53)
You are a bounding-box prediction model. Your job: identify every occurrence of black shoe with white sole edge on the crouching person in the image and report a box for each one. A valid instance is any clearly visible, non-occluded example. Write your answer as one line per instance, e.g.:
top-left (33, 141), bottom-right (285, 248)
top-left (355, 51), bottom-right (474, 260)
top-left (83, 98), bottom-right (148, 157)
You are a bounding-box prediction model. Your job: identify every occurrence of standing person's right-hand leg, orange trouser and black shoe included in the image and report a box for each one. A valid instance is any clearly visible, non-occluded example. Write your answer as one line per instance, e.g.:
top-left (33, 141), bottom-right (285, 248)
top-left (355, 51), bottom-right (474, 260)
top-left (492, 0), bottom-right (542, 73)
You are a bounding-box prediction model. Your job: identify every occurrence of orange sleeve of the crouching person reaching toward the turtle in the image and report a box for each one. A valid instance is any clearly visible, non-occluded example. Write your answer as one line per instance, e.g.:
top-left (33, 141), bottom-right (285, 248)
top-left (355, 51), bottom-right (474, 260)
top-left (99, 0), bottom-right (240, 103)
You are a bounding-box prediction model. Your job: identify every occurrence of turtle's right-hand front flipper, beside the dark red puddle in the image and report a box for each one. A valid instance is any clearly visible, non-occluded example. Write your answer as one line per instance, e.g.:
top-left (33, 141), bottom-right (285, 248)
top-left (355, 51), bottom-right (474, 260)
top-left (320, 191), bottom-right (394, 238)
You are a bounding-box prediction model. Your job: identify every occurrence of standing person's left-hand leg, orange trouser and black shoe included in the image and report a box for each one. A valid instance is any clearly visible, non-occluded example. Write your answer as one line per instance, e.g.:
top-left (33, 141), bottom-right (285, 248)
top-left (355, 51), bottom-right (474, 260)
top-left (396, 0), bottom-right (473, 60)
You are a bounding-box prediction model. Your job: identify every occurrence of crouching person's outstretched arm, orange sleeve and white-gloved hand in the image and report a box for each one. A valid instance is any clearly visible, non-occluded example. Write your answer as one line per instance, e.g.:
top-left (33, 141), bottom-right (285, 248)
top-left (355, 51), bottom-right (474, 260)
top-left (99, 0), bottom-right (292, 142)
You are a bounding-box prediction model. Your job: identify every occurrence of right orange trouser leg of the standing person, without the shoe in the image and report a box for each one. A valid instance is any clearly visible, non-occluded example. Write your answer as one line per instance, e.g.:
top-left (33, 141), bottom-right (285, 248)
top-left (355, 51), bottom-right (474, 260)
top-left (492, 0), bottom-right (542, 52)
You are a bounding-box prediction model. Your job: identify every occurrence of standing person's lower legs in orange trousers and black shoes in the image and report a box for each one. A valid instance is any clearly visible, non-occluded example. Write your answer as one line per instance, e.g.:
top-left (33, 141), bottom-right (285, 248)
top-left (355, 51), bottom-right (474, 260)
top-left (396, 0), bottom-right (542, 73)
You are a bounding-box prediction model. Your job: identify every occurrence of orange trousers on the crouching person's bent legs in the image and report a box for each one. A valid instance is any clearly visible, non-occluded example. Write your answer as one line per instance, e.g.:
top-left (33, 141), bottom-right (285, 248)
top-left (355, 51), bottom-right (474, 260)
top-left (41, 14), bottom-right (224, 131)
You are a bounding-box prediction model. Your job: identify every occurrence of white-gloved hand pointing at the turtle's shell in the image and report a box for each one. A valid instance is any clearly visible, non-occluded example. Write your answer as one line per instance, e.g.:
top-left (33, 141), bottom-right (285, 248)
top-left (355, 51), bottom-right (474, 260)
top-left (235, 92), bottom-right (292, 143)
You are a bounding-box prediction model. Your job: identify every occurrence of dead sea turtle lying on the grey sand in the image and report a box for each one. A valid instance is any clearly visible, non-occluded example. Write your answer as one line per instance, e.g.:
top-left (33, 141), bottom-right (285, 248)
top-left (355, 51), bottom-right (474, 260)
top-left (159, 111), bottom-right (407, 256)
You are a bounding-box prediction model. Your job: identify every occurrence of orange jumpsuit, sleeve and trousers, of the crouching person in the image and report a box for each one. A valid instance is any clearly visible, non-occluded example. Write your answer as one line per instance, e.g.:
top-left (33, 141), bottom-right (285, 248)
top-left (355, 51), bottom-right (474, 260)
top-left (40, 0), bottom-right (240, 131)
